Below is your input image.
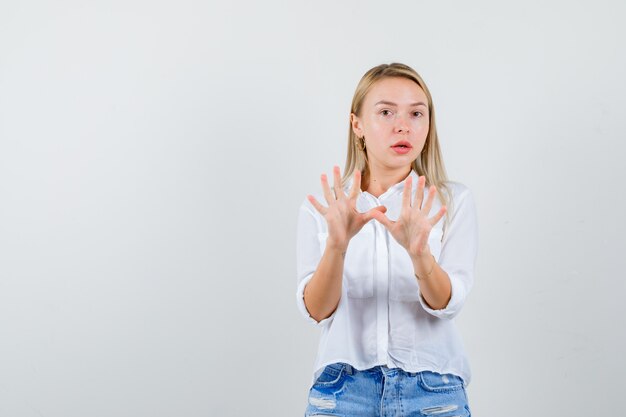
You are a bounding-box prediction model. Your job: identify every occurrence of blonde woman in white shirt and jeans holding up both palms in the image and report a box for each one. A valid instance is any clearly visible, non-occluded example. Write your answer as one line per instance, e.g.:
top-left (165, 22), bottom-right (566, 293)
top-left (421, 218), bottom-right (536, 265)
top-left (297, 63), bottom-right (478, 417)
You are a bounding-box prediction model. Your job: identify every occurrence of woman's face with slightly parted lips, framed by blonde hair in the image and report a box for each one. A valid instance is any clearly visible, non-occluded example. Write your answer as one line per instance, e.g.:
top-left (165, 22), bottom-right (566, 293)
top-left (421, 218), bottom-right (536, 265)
top-left (350, 77), bottom-right (429, 171)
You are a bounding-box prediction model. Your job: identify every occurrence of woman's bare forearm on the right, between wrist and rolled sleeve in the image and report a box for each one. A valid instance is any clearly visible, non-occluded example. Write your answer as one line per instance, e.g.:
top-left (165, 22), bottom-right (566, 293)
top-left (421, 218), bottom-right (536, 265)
top-left (411, 252), bottom-right (452, 310)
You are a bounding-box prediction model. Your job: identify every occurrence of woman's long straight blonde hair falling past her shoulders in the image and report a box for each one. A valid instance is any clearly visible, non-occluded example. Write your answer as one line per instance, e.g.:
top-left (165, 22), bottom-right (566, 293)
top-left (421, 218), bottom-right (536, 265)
top-left (342, 63), bottom-right (453, 229)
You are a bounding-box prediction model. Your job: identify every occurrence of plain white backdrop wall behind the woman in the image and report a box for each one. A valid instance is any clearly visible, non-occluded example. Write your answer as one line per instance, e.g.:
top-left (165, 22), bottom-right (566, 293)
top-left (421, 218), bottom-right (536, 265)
top-left (0, 0), bottom-right (626, 417)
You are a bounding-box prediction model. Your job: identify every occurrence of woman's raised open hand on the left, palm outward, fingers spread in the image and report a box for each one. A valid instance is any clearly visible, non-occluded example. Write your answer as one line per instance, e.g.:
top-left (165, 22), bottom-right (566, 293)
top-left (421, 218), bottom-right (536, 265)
top-left (307, 165), bottom-right (387, 253)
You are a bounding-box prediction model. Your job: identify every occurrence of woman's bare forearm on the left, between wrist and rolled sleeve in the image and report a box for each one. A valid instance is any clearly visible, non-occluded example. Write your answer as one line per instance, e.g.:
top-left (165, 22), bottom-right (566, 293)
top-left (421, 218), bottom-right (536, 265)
top-left (304, 245), bottom-right (346, 322)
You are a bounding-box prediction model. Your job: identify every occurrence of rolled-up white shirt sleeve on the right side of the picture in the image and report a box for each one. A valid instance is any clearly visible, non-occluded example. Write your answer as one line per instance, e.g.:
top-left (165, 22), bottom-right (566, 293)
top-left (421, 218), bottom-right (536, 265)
top-left (420, 184), bottom-right (478, 319)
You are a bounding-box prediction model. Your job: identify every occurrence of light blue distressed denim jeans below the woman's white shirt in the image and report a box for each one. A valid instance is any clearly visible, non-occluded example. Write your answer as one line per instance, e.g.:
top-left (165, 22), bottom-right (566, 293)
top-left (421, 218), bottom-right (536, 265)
top-left (305, 363), bottom-right (471, 417)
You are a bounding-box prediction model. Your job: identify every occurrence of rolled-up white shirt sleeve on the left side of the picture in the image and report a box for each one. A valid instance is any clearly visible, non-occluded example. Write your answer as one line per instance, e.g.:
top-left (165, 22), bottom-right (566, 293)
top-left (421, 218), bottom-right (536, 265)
top-left (296, 200), bottom-right (337, 327)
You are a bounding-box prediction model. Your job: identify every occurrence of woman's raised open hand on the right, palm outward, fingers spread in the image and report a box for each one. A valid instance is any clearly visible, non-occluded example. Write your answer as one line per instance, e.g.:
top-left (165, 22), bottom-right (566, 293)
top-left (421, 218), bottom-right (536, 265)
top-left (373, 176), bottom-right (446, 259)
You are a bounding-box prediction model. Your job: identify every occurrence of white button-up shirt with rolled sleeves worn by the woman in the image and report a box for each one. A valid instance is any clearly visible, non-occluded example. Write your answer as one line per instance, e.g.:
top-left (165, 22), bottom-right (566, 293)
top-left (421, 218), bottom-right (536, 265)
top-left (296, 171), bottom-right (478, 385)
